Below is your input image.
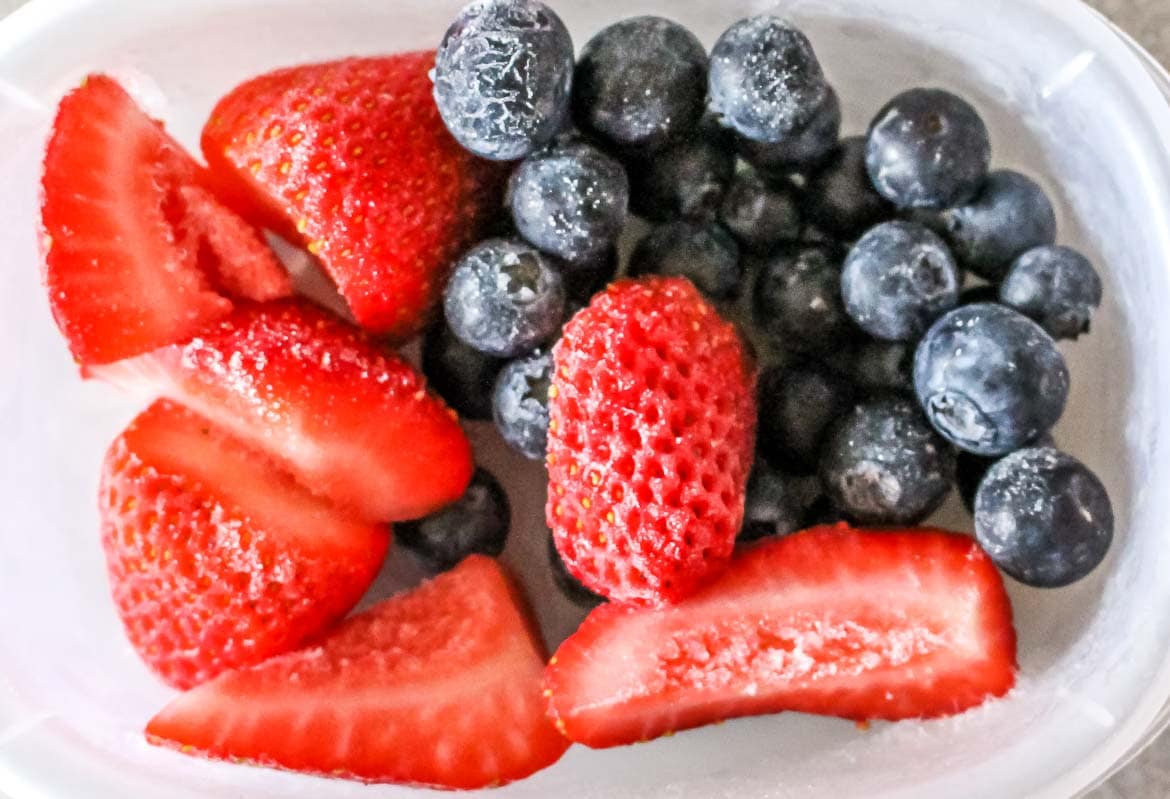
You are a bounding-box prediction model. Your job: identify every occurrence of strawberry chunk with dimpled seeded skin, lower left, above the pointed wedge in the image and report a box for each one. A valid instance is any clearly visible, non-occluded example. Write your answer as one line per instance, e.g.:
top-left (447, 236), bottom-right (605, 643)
top-left (101, 401), bottom-right (390, 688)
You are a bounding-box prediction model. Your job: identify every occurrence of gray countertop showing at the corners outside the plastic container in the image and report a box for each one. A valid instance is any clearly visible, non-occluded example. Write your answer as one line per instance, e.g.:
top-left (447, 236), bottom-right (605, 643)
top-left (0, 0), bottom-right (1170, 799)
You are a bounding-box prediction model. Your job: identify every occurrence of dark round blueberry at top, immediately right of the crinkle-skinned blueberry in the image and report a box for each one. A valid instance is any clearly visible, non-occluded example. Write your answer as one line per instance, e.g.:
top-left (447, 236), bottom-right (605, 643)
top-left (573, 16), bottom-right (707, 151)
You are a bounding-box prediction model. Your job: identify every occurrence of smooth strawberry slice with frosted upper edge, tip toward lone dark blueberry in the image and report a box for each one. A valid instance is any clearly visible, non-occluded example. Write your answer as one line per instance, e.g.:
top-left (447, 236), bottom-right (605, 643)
top-left (90, 301), bottom-right (473, 522)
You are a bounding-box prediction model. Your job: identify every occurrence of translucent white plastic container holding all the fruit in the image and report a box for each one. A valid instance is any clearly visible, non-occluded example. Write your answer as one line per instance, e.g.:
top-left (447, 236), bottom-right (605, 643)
top-left (0, 0), bottom-right (1170, 799)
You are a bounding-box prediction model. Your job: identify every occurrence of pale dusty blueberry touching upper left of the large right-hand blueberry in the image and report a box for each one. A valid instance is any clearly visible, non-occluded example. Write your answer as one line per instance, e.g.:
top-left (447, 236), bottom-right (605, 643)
top-left (841, 221), bottom-right (959, 342)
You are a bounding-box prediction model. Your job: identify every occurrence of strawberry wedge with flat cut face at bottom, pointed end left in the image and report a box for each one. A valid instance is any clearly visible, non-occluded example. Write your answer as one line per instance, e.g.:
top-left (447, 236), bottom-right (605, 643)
top-left (146, 555), bottom-right (569, 788)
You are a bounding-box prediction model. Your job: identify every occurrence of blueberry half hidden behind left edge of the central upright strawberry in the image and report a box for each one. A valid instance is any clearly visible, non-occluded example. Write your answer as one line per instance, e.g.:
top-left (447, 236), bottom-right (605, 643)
top-left (491, 350), bottom-right (552, 461)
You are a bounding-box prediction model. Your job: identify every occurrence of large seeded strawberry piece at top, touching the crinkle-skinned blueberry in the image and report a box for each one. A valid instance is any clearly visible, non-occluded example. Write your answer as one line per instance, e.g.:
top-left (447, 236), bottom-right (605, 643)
top-left (202, 50), bottom-right (502, 338)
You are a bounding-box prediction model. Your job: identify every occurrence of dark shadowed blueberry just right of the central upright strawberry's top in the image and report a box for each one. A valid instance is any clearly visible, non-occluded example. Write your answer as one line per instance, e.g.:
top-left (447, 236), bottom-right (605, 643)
top-left (752, 247), bottom-right (854, 353)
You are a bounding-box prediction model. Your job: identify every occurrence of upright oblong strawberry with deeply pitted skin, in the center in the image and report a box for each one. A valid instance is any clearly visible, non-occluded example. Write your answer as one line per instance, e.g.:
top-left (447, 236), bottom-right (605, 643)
top-left (548, 277), bottom-right (756, 604)
